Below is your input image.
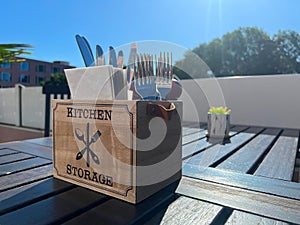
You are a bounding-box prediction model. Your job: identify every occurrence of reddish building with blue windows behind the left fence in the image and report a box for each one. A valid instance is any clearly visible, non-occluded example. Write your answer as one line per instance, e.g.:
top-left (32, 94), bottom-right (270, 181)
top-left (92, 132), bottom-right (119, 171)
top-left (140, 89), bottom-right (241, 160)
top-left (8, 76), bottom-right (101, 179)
top-left (0, 58), bottom-right (74, 88)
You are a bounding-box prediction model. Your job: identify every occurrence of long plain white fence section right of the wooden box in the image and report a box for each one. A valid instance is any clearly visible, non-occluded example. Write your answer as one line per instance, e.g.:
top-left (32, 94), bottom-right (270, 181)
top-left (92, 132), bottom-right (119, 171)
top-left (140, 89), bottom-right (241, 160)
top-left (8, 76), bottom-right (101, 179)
top-left (181, 74), bottom-right (300, 129)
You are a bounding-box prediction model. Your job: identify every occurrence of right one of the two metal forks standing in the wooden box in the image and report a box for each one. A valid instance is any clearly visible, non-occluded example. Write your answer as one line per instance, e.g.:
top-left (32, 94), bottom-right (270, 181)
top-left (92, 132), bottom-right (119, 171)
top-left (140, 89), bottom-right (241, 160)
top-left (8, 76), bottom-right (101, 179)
top-left (155, 52), bottom-right (173, 100)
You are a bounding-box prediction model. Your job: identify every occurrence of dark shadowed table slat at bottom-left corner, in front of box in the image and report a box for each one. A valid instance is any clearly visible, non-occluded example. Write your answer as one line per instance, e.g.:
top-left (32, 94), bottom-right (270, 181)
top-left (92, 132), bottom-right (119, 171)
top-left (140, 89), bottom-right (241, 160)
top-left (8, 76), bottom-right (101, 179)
top-left (0, 187), bottom-right (109, 225)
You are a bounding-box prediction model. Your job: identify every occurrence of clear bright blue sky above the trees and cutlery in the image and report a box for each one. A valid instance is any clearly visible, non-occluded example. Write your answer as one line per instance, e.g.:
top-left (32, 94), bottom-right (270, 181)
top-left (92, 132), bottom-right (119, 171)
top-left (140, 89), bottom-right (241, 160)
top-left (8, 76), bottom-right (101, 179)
top-left (0, 0), bottom-right (300, 67)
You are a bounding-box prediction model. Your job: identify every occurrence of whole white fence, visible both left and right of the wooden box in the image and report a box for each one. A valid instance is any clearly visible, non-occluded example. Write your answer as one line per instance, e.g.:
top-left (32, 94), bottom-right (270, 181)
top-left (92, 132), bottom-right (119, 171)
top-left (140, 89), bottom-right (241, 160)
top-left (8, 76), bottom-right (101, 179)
top-left (0, 74), bottom-right (300, 129)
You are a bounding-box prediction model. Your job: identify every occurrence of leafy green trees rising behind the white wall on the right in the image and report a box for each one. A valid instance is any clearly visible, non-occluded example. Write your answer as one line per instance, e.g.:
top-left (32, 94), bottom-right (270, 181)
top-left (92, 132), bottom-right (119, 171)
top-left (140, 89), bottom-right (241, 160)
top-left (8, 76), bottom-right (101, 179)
top-left (175, 27), bottom-right (300, 78)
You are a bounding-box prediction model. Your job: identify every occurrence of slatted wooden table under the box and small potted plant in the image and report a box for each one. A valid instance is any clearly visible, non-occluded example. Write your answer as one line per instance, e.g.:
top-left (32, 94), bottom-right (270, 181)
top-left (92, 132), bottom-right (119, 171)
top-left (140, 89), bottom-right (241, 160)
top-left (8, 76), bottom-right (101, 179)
top-left (0, 126), bottom-right (300, 225)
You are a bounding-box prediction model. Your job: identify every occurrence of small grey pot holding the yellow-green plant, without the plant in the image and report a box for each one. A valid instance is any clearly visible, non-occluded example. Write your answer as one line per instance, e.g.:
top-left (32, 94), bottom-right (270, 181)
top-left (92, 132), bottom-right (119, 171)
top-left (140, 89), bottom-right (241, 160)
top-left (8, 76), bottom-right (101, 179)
top-left (207, 113), bottom-right (230, 139)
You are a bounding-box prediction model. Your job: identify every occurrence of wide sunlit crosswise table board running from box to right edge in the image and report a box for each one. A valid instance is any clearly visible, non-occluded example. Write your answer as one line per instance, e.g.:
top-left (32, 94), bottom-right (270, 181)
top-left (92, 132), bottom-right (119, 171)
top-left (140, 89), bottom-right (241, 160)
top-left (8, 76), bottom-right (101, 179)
top-left (176, 177), bottom-right (300, 223)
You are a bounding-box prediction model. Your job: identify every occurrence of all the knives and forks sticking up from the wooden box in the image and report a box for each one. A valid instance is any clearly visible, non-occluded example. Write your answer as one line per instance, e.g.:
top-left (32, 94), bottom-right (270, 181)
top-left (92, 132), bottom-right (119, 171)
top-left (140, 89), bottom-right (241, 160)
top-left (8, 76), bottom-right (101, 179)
top-left (75, 35), bottom-right (182, 100)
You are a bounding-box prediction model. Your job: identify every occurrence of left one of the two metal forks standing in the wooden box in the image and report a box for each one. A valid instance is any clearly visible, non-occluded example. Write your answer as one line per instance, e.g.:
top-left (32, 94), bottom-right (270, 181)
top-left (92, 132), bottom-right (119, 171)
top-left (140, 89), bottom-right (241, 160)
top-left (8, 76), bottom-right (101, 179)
top-left (134, 54), bottom-right (157, 100)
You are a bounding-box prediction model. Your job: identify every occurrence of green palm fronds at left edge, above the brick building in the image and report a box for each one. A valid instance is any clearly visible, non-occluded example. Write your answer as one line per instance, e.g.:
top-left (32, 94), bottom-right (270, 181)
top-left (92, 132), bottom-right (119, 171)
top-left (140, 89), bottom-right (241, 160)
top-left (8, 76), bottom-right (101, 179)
top-left (0, 44), bottom-right (33, 64)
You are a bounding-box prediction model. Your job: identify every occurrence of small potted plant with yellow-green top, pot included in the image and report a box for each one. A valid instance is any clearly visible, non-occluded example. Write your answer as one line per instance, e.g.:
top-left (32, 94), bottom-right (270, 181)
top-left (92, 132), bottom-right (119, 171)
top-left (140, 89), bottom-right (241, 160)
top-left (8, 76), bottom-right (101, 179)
top-left (207, 106), bottom-right (231, 139)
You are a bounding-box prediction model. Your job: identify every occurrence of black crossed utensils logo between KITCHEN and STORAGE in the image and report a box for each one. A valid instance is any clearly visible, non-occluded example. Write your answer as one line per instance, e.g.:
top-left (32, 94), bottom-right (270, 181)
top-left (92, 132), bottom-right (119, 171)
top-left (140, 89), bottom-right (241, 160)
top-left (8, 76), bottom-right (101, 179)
top-left (75, 123), bottom-right (101, 167)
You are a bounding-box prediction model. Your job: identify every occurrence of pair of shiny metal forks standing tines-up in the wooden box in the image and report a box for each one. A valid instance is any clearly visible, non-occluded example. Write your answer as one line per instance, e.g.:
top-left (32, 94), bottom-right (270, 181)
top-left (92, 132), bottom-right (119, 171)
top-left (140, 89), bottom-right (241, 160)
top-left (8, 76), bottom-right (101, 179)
top-left (134, 52), bottom-right (173, 100)
